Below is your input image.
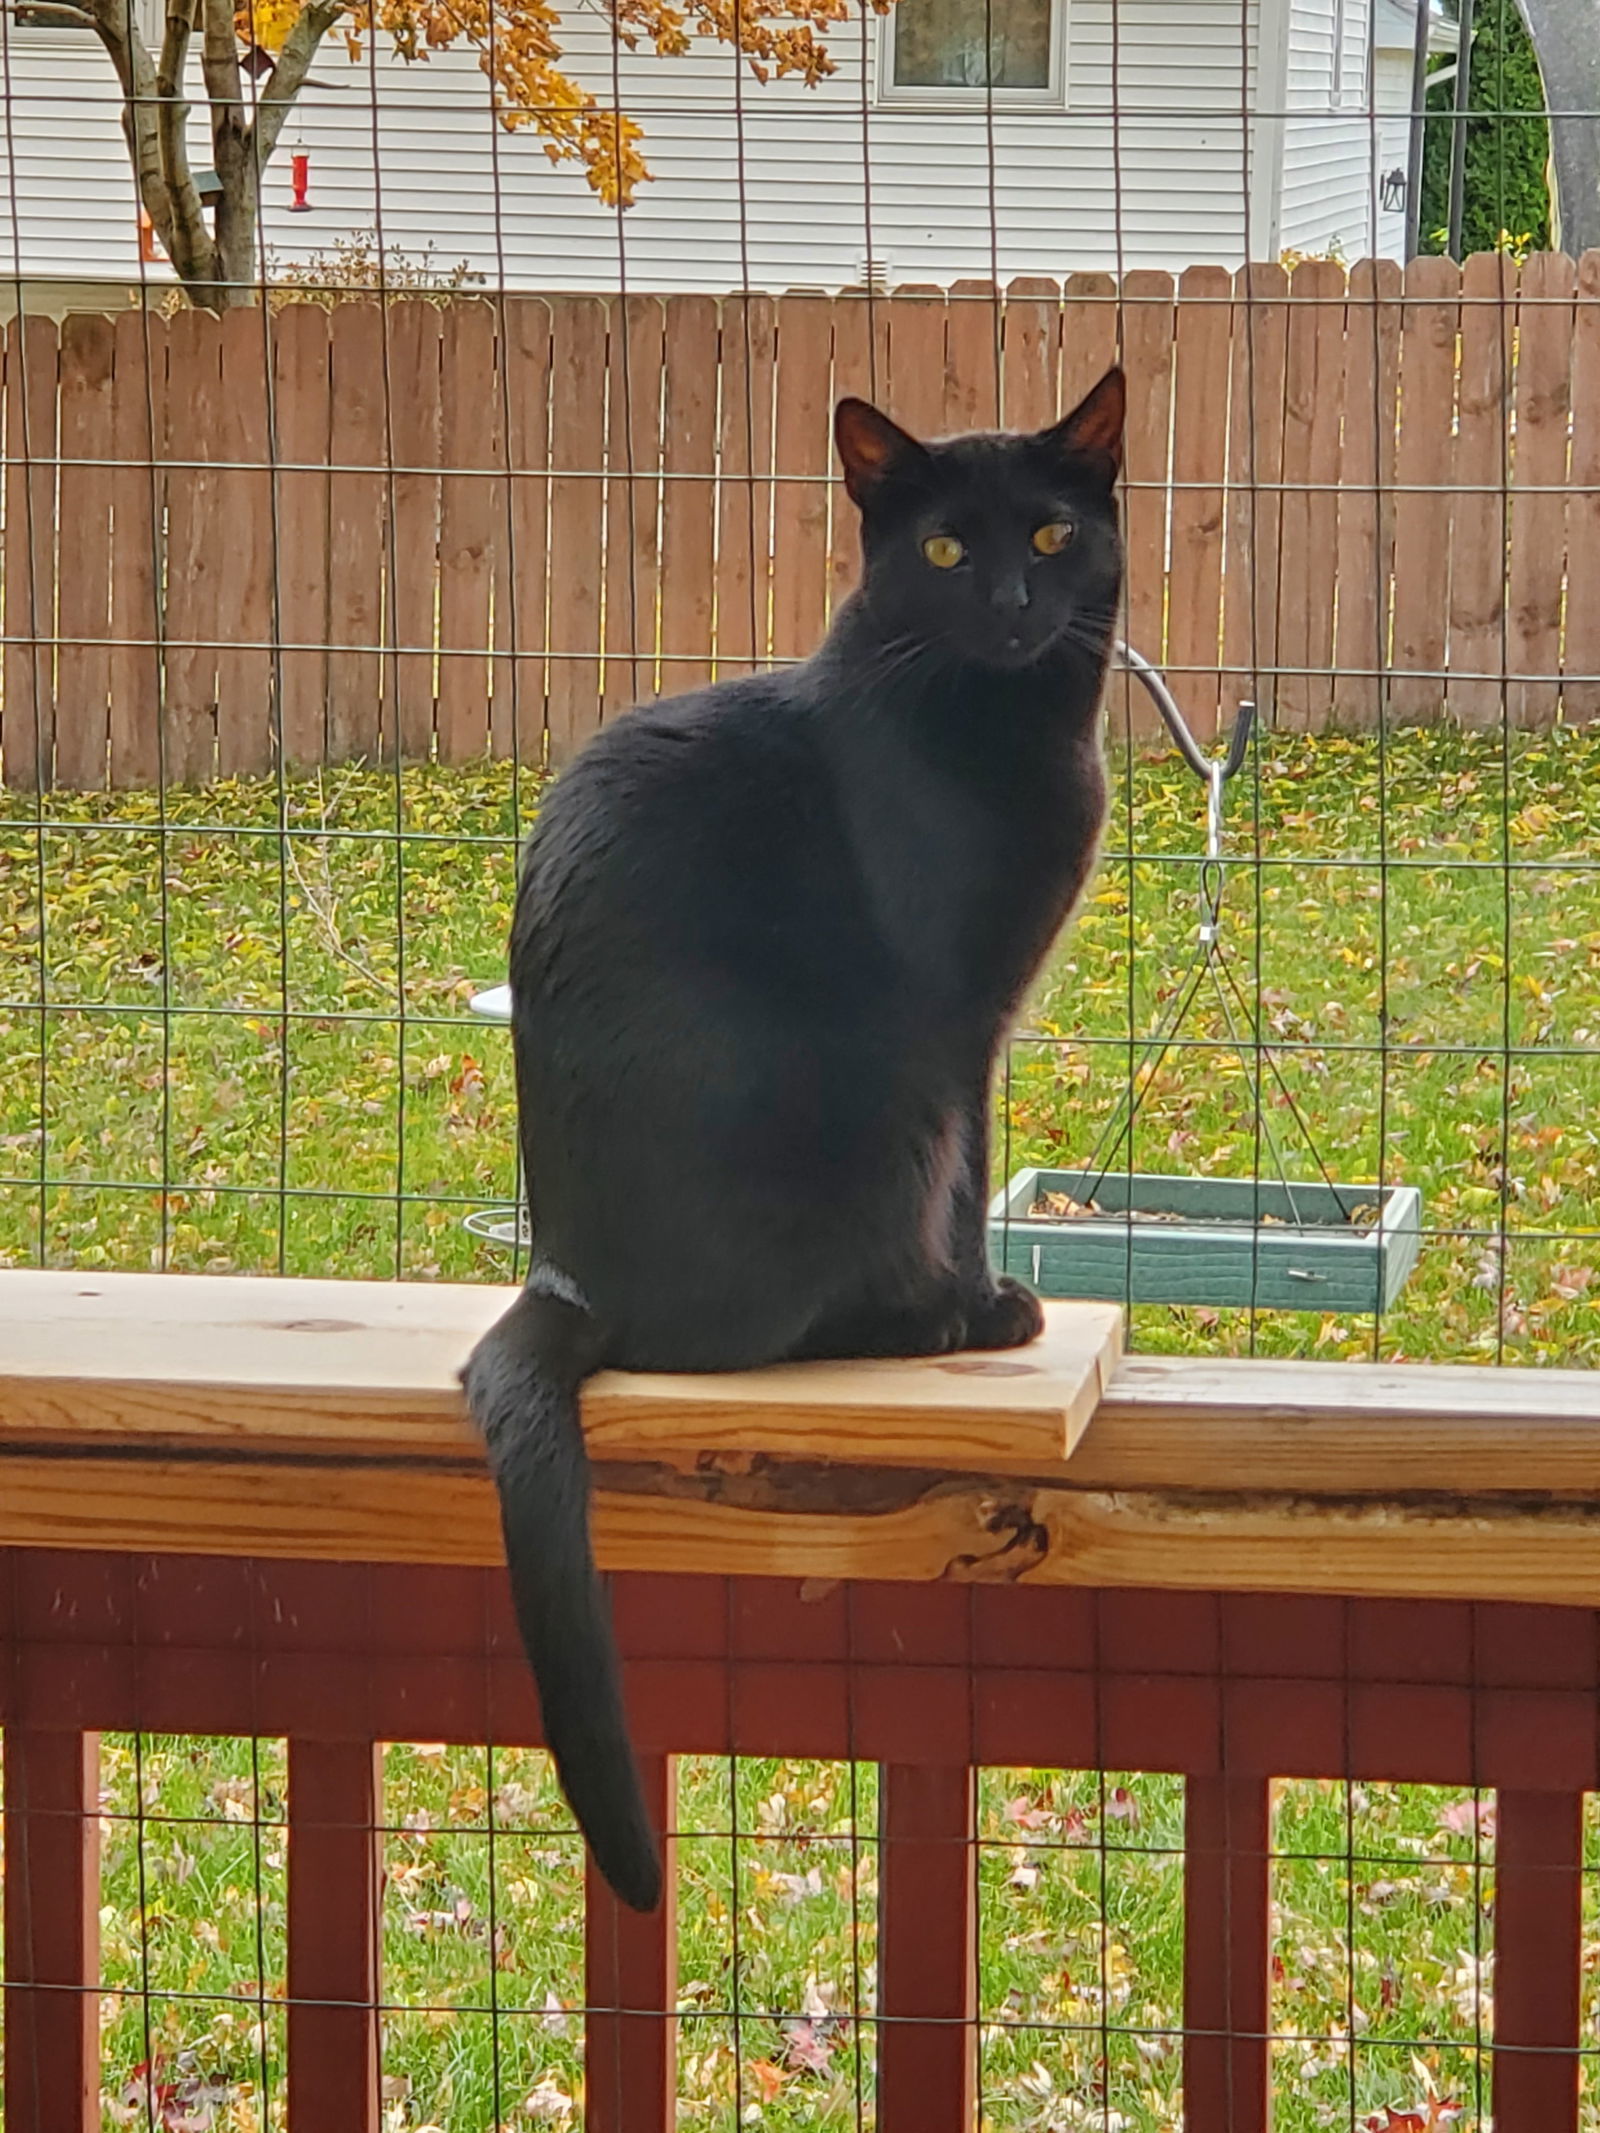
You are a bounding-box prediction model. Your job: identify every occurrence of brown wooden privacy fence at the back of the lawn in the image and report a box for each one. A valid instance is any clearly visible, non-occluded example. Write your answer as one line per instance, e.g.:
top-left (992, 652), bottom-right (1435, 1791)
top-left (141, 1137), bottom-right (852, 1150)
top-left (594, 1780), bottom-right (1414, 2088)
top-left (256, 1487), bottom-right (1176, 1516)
top-left (0, 254), bottom-right (1600, 787)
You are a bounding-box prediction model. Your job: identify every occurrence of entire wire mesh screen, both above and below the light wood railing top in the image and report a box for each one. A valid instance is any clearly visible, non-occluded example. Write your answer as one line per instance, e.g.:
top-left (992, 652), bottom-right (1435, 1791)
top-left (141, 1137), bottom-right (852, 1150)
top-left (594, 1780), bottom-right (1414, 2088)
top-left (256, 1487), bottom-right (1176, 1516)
top-left (0, 0), bottom-right (1600, 2133)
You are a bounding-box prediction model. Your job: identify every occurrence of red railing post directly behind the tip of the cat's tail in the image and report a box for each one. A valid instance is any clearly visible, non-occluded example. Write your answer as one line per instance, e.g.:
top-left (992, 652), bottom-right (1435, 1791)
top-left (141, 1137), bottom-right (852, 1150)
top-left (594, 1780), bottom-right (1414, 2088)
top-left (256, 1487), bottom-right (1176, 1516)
top-left (582, 1755), bottom-right (678, 2133)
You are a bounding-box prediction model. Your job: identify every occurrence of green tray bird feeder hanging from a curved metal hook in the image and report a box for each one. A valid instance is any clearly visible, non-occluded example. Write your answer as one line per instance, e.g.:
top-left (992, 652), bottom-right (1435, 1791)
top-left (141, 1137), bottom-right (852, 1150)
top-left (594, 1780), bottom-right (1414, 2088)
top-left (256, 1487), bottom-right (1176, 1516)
top-left (990, 644), bottom-right (1423, 1314)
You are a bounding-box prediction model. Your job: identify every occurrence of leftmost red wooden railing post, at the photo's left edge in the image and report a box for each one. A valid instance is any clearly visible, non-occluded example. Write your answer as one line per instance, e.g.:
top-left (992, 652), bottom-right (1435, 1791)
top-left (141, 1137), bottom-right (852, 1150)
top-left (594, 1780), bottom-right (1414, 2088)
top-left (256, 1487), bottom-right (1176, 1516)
top-left (4, 1726), bottom-right (100, 2133)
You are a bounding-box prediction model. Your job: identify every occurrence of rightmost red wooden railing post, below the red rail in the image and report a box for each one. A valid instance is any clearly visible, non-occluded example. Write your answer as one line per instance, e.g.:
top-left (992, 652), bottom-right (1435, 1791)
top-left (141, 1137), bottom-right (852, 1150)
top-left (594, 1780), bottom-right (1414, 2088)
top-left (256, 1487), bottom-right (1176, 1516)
top-left (1493, 1792), bottom-right (1583, 2133)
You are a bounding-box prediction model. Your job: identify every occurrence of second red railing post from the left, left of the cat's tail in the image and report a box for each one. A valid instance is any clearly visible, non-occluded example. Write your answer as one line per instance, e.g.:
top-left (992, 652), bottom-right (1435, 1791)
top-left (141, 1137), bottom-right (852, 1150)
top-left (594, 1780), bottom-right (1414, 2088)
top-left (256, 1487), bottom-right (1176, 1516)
top-left (288, 1738), bottom-right (382, 2133)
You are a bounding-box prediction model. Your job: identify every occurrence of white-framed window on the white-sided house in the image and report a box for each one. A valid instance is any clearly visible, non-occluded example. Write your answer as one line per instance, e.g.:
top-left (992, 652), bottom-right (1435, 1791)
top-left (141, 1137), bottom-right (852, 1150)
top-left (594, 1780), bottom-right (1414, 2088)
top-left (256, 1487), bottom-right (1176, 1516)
top-left (879, 0), bottom-right (1067, 105)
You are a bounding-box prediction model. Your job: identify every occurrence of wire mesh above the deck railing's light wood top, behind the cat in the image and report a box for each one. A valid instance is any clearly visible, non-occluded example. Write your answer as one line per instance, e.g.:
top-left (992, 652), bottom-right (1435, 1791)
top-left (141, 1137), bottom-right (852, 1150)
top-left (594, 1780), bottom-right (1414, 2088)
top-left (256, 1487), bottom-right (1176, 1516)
top-left (0, 0), bottom-right (1600, 1361)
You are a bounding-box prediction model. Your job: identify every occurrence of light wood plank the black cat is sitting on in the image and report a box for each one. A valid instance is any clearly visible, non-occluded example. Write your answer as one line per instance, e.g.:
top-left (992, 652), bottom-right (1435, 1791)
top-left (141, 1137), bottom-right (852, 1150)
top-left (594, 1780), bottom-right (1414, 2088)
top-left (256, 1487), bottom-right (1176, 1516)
top-left (0, 1269), bottom-right (1120, 1470)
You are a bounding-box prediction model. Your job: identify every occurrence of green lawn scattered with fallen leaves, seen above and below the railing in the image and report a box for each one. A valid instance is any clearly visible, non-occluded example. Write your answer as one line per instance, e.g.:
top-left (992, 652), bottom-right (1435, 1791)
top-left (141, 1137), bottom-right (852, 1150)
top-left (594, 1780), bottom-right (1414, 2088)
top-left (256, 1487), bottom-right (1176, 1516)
top-left (0, 732), bottom-right (1600, 2133)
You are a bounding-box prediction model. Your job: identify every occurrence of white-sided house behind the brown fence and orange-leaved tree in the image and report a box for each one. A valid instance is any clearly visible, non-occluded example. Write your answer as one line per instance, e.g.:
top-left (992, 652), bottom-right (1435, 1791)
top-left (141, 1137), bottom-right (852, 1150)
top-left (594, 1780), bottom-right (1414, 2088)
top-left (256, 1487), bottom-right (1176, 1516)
top-left (0, 0), bottom-right (1450, 290)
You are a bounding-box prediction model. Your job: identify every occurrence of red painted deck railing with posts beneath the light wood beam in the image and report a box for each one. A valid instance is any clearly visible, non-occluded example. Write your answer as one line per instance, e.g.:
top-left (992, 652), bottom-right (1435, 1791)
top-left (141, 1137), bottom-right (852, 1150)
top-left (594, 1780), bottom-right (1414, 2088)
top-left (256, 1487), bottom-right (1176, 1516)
top-left (0, 1549), bottom-right (1600, 2133)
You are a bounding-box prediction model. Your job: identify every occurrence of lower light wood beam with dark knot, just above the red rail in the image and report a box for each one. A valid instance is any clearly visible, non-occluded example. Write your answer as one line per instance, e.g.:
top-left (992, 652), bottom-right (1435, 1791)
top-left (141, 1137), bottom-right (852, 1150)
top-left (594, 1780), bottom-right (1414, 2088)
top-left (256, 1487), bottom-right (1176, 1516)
top-left (0, 1440), bottom-right (1600, 1606)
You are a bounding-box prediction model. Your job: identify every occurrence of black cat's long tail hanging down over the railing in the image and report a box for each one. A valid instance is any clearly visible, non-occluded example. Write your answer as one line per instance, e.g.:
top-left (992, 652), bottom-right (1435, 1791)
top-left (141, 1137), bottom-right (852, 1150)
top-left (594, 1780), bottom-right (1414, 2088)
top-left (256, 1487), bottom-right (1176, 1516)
top-left (461, 1267), bottom-right (661, 1911)
